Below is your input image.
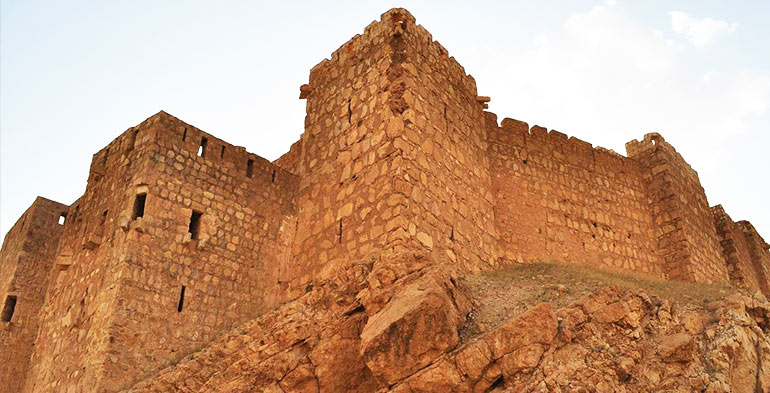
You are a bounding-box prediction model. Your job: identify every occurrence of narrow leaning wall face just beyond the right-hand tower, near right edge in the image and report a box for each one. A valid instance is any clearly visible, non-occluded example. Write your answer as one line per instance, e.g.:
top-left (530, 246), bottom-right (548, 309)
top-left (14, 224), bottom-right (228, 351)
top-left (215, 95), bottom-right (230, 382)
top-left (711, 205), bottom-right (766, 292)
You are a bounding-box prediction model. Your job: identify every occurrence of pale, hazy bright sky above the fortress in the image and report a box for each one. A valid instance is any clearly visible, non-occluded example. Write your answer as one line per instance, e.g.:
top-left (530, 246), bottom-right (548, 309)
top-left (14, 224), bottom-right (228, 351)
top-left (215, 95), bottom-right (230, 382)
top-left (0, 0), bottom-right (770, 240)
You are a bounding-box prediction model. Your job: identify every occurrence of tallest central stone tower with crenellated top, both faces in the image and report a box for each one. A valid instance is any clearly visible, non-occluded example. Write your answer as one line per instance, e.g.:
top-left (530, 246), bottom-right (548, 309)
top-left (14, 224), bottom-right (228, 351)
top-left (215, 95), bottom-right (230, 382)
top-left (276, 9), bottom-right (497, 288)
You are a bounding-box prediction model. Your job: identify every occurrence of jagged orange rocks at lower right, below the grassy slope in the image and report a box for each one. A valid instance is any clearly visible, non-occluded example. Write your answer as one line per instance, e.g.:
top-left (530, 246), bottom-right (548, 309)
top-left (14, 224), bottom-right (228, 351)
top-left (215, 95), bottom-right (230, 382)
top-left (390, 287), bottom-right (770, 393)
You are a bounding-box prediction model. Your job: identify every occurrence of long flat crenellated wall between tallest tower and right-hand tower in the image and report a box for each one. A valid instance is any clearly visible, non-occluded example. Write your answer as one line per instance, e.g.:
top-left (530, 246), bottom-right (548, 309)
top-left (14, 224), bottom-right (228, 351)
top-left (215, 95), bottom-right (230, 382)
top-left (487, 113), bottom-right (663, 277)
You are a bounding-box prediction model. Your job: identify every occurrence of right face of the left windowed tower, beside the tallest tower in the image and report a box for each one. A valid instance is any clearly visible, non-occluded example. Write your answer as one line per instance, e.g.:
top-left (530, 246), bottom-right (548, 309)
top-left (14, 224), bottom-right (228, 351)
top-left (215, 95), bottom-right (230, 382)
top-left (103, 115), bottom-right (297, 387)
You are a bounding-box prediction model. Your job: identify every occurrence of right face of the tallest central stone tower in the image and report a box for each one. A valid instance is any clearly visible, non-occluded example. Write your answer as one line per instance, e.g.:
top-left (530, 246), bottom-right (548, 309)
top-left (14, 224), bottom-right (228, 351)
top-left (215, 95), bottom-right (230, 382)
top-left (393, 13), bottom-right (498, 271)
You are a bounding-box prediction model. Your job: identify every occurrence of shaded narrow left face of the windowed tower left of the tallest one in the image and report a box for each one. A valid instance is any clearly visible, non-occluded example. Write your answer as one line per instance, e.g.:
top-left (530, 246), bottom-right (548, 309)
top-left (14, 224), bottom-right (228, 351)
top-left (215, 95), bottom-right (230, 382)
top-left (25, 118), bottom-right (159, 392)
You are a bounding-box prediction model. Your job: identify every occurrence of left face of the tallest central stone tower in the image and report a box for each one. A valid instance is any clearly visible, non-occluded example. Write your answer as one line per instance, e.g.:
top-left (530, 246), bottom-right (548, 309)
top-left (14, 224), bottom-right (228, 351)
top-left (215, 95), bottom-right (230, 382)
top-left (276, 11), bottom-right (416, 290)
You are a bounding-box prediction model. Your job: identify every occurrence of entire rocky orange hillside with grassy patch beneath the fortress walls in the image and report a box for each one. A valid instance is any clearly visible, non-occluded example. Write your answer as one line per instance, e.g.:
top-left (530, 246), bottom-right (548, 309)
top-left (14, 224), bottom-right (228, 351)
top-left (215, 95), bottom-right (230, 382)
top-left (126, 257), bottom-right (770, 393)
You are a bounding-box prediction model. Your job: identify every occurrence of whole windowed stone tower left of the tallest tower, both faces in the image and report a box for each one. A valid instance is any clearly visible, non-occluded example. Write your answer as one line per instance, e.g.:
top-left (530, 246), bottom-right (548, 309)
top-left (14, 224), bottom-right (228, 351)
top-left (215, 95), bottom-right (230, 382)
top-left (22, 113), bottom-right (297, 391)
